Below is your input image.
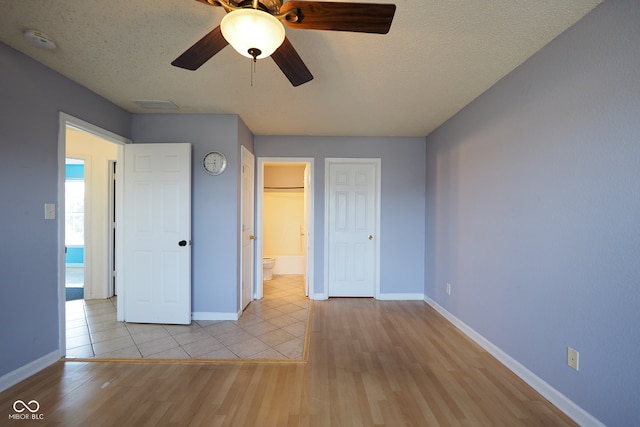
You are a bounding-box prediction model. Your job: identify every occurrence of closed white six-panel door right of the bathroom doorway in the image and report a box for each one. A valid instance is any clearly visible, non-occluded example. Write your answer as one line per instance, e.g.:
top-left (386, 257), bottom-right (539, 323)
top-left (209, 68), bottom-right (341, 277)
top-left (327, 159), bottom-right (379, 297)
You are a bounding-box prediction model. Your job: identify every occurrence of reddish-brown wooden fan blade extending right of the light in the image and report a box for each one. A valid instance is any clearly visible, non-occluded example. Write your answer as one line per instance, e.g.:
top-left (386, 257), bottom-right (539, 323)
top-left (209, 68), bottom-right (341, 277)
top-left (280, 1), bottom-right (396, 34)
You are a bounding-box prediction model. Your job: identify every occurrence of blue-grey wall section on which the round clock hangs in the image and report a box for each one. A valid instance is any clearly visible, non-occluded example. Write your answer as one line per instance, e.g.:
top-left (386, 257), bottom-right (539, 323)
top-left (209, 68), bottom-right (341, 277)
top-left (133, 114), bottom-right (252, 314)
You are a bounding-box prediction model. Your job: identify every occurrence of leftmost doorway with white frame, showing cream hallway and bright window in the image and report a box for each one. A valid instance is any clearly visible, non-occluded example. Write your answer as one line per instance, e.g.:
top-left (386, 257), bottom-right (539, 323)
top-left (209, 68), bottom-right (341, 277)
top-left (58, 113), bottom-right (129, 357)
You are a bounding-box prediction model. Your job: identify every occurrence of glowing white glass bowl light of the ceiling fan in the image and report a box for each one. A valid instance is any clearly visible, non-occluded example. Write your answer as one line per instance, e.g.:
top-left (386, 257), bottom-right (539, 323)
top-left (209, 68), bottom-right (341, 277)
top-left (220, 8), bottom-right (285, 59)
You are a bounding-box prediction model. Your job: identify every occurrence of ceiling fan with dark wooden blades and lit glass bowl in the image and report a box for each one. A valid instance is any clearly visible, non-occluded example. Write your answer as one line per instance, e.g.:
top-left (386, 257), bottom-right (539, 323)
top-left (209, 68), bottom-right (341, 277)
top-left (171, 0), bottom-right (396, 86)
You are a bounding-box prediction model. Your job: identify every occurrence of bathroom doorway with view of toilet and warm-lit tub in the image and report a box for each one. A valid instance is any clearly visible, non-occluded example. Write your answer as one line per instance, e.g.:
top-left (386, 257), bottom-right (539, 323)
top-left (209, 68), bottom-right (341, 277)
top-left (255, 157), bottom-right (314, 299)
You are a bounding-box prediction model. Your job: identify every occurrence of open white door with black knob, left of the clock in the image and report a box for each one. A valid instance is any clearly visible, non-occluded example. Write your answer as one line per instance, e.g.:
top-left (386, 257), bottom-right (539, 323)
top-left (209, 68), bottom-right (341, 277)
top-left (119, 144), bottom-right (191, 324)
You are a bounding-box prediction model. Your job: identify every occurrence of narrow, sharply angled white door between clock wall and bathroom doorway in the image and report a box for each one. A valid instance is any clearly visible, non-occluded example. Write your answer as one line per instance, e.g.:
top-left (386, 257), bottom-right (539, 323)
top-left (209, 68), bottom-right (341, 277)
top-left (240, 147), bottom-right (256, 310)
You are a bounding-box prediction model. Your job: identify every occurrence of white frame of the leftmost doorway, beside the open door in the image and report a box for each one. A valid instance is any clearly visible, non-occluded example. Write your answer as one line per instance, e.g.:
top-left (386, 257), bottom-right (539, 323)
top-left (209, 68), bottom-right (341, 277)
top-left (57, 112), bottom-right (131, 357)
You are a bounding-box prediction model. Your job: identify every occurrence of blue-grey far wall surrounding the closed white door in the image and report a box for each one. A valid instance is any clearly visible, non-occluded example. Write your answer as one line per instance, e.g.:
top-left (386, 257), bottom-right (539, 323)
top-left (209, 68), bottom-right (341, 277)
top-left (254, 136), bottom-right (425, 294)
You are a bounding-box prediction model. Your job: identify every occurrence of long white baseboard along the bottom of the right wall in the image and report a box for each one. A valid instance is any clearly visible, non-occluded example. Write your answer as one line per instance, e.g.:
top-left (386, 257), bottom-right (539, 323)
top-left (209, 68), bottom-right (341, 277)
top-left (424, 295), bottom-right (605, 427)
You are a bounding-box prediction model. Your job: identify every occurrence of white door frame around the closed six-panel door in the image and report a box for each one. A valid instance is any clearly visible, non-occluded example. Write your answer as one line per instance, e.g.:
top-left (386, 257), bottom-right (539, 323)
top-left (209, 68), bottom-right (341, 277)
top-left (323, 157), bottom-right (382, 299)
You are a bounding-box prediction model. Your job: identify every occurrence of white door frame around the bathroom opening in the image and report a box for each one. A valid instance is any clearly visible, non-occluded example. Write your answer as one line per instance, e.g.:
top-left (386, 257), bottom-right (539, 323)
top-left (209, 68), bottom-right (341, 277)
top-left (254, 157), bottom-right (322, 299)
